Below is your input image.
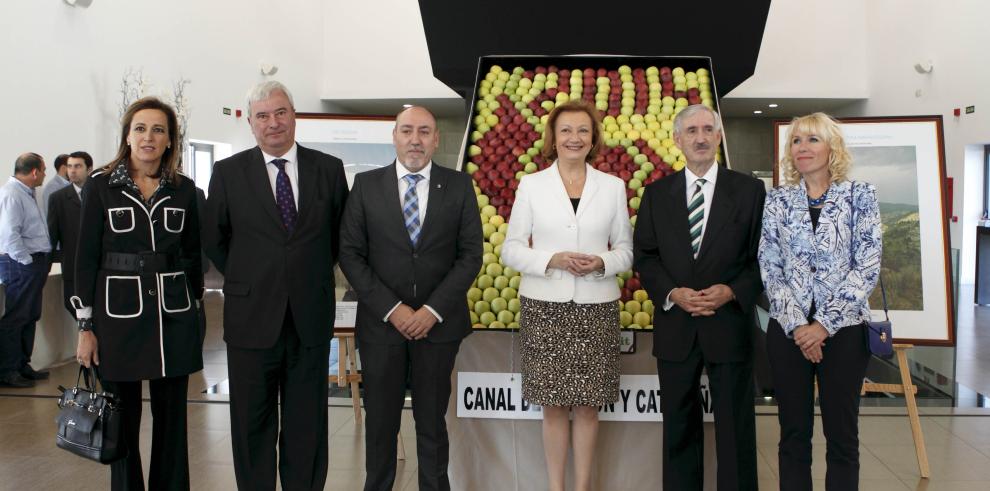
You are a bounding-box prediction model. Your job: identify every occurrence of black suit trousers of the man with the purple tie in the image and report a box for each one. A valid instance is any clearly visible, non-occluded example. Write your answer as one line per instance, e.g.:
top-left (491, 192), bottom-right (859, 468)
top-left (227, 307), bottom-right (330, 491)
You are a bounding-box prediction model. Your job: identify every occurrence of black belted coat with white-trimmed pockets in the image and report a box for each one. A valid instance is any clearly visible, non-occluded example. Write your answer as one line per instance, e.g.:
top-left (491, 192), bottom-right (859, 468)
top-left (75, 168), bottom-right (203, 382)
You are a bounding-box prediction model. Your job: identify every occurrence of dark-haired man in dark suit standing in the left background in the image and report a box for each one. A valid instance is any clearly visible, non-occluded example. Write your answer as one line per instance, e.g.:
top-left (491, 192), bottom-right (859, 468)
top-left (48, 152), bottom-right (93, 318)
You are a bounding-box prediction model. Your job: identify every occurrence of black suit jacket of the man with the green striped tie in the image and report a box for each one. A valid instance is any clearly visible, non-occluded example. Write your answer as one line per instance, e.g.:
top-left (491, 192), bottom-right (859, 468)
top-left (633, 167), bottom-right (766, 363)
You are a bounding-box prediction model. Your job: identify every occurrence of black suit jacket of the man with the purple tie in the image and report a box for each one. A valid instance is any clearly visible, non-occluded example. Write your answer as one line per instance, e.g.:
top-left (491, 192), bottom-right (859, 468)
top-left (203, 146), bottom-right (347, 349)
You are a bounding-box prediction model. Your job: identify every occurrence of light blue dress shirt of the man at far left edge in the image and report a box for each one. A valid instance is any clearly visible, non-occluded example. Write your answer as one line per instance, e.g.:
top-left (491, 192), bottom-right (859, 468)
top-left (0, 177), bottom-right (52, 265)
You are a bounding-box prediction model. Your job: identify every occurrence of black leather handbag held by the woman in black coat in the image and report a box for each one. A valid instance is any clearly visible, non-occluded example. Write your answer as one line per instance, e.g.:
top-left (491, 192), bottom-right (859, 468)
top-left (55, 366), bottom-right (127, 464)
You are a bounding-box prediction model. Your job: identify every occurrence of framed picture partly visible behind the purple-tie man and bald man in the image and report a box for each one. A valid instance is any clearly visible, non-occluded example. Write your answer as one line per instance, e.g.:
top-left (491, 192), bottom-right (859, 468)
top-left (296, 113), bottom-right (395, 187)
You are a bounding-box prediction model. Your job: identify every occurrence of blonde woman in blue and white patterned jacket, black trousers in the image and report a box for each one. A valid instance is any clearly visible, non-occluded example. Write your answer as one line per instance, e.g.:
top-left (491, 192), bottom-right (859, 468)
top-left (759, 113), bottom-right (882, 491)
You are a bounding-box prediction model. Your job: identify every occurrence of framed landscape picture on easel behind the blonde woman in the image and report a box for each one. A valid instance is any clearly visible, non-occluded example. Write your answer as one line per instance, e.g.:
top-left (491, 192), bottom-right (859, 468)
top-left (774, 116), bottom-right (955, 346)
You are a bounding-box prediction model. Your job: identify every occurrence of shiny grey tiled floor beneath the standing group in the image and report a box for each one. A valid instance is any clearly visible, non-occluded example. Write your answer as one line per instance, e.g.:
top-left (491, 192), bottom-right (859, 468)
top-left (0, 295), bottom-right (990, 491)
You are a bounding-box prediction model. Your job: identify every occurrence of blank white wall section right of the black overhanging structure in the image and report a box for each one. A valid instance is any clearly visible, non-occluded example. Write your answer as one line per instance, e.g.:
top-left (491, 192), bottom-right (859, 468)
top-left (725, 0), bottom-right (872, 99)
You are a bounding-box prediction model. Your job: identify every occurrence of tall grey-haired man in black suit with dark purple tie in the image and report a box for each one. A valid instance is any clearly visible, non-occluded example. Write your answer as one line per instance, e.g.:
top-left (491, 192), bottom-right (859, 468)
top-left (203, 81), bottom-right (347, 490)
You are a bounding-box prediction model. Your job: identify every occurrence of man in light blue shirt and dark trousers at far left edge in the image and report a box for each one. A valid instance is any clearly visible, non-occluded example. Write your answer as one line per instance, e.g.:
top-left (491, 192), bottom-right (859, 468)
top-left (0, 153), bottom-right (52, 388)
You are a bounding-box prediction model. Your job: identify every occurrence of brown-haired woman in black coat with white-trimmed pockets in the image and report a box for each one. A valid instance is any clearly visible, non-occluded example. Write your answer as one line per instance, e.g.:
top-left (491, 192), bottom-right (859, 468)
top-left (71, 97), bottom-right (203, 490)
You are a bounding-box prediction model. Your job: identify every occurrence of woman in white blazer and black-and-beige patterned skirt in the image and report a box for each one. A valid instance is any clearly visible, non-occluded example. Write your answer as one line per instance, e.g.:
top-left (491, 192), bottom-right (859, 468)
top-left (502, 101), bottom-right (632, 491)
